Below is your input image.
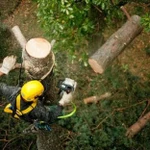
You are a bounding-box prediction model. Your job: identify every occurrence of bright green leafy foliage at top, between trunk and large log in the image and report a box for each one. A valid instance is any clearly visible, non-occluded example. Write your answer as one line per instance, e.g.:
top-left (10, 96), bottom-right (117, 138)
top-left (37, 0), bottom-right (122, 63)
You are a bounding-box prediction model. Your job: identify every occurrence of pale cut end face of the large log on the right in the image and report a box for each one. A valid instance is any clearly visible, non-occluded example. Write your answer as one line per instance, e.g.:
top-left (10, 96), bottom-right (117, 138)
top-left (88, 58), bottom-right (104, 74)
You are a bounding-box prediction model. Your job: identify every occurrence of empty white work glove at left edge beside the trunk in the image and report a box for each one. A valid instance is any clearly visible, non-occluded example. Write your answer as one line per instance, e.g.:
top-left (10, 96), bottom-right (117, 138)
top-left (0, 55), bottom-right (17, 74)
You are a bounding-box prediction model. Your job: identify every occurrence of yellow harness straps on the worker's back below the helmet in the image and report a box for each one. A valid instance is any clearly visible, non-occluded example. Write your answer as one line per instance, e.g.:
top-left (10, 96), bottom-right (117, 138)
top-left (4, 94), bottom-right (37, 119)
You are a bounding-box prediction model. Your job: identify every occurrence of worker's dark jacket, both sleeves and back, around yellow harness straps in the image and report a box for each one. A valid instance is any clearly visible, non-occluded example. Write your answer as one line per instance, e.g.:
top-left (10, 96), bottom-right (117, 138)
top-left (0, 83), bottom-right (63, 123)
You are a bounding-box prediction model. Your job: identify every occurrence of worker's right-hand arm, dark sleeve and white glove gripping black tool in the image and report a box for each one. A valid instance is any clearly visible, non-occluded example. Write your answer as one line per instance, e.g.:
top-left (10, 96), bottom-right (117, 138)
top-left (30, 78), bottom-right (77, 123)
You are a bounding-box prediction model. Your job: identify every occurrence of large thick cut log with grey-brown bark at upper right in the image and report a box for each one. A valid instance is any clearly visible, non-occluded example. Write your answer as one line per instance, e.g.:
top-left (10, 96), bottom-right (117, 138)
top-left (88, 15), bottom-right (143, 74)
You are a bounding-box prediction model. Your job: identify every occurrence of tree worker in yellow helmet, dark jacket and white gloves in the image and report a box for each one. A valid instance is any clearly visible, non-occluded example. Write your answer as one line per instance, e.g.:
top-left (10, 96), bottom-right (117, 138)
top-left (0, 56), bottom-right (77, 132)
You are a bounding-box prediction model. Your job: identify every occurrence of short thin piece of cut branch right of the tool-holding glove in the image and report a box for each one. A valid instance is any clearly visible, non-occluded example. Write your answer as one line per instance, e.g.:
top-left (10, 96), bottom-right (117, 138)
top-left (83, 92), bottom-right (111, 104)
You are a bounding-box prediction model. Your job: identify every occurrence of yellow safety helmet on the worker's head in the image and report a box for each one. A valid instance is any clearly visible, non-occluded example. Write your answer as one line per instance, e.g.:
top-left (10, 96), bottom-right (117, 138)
top-left (21, 80), bottom-right (44, 102)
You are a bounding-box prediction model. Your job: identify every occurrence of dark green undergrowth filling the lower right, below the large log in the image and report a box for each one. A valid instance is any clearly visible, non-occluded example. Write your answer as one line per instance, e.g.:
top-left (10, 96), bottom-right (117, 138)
top-left (59, 66), bottom-right (150, 150)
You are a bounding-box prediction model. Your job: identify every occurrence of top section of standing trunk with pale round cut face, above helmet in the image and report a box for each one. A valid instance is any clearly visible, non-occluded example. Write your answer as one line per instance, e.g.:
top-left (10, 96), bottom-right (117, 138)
top-left (24, 38), bottom-right (55, 80)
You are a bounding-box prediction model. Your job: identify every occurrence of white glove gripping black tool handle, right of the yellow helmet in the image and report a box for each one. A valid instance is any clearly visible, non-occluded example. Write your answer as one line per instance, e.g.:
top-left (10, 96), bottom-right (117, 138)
top-left (59, 78), bottom-right (77, 106)
